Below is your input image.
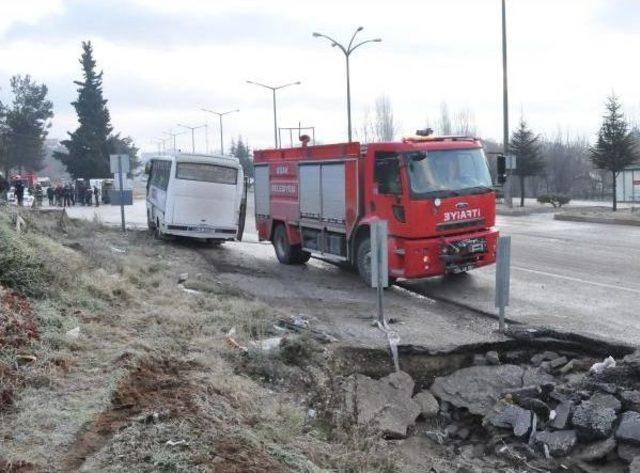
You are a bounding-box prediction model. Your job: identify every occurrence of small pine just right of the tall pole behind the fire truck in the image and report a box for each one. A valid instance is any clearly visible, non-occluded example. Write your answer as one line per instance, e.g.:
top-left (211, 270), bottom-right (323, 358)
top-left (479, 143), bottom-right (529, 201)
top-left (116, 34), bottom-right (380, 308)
top-left (509, 118), bottom-right (545, 207)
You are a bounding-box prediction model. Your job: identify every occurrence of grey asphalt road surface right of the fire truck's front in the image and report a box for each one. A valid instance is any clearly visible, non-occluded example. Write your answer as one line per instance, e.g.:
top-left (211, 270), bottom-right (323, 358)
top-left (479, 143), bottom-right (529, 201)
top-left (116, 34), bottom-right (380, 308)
top-left (409, 214), bottom-right (640, 344)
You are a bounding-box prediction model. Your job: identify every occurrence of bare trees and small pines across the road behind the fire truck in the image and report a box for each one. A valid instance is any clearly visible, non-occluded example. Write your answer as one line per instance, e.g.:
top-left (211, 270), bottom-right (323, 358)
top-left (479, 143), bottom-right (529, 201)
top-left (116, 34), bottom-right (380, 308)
top-left (358, 94), bottom-right (640, 211)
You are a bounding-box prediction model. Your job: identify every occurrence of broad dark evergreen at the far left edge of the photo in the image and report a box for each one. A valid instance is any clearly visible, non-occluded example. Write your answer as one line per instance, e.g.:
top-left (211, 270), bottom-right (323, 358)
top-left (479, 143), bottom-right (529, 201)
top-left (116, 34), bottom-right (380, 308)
top-left (0, 75), bottom-right (53, 172)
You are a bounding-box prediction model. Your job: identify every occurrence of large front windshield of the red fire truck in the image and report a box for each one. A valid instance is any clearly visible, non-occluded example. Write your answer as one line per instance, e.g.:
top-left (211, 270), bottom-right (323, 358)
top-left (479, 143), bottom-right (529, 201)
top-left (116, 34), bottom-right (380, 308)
top-left (405, 148), bottom-right (492, 198)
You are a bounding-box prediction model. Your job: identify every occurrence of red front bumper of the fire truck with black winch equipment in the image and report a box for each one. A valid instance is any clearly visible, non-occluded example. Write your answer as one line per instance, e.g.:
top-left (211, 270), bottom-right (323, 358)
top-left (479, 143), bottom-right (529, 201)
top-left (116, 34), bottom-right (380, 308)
top-left (389, 229), bottom-right (498, 279)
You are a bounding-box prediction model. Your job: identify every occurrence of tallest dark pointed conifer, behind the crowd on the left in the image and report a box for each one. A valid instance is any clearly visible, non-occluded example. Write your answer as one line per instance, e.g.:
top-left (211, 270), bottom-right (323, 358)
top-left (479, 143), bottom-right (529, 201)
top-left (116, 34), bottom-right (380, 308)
top-left (55, 41), bottom-right (113, 179)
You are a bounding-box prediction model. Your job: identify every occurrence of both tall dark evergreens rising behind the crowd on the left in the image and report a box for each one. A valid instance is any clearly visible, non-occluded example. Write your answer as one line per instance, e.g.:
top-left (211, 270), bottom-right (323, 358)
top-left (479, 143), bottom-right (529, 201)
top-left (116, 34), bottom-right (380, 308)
top-left (0, 41), bottom-right (138, 183)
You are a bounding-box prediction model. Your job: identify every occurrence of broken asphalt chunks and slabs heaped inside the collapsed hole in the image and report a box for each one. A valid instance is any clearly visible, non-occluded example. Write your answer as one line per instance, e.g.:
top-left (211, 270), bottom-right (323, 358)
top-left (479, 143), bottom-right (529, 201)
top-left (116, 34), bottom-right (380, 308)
top-left (347, 350), bottom-right (640, 473)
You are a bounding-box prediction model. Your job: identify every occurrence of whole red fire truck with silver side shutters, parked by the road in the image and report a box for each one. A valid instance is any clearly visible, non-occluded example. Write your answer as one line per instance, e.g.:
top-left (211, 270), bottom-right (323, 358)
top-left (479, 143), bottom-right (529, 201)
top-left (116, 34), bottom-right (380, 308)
top-left (254, 135), bottom-right (498, 283)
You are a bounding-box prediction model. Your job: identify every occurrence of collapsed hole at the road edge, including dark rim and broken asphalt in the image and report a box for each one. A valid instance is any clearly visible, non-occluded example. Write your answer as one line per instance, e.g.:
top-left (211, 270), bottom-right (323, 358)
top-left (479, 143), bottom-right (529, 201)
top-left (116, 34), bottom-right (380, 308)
top-left (334, 329), bottom-right (640, 472)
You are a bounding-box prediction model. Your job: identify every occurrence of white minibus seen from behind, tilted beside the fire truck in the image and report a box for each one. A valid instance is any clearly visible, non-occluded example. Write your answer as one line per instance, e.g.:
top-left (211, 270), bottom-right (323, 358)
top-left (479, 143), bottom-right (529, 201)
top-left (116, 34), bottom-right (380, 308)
top-left (146, 153), bottom-right (247, 243)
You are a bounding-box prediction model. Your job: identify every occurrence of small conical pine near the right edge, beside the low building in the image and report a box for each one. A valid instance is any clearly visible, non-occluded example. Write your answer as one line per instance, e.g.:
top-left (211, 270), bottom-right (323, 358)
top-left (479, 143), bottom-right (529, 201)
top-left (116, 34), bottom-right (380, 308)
top-left (591, 94), bottom-right (639, 212)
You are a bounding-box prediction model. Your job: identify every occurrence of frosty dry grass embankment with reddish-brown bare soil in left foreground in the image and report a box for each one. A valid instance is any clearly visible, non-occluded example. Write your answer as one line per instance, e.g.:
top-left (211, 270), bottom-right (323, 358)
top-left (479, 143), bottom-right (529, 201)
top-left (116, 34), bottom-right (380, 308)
top-left (0, 207), bottom-right (399, 472)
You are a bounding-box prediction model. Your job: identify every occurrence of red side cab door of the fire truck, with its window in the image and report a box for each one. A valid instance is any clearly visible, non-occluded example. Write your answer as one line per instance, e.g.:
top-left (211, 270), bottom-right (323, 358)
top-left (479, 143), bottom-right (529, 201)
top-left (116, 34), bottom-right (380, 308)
top-left (372, 151), bottom-right (404, 231)
